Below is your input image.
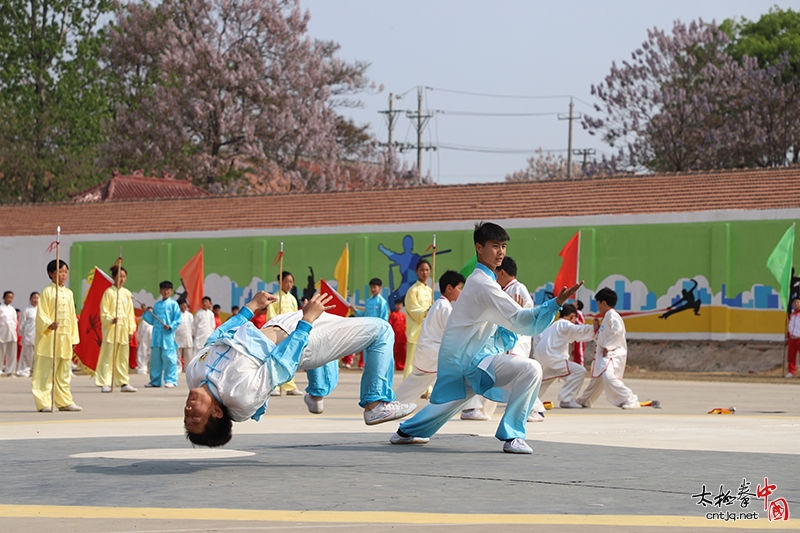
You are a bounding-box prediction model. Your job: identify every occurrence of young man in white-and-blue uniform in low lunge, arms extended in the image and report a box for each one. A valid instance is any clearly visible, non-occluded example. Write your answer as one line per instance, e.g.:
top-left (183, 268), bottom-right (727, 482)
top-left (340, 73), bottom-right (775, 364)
top-left (389, 222), bottom-right (582, 453)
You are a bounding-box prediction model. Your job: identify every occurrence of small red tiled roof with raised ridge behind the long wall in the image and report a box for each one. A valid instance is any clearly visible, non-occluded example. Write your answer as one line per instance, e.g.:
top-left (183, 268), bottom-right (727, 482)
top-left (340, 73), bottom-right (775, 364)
top-left (72, 175), bottom-right (211, 203)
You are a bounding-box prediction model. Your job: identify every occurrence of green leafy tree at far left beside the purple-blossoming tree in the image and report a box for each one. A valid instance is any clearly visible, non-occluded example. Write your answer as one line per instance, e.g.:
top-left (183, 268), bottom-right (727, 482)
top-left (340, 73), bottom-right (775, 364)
top-left (0, 0), bottom-right (112, 203)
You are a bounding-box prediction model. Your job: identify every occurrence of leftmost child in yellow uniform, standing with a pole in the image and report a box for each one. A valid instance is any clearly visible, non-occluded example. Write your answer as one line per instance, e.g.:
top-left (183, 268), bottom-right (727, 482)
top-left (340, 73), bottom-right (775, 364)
top-left (31, 261), bottom-right (82, 412)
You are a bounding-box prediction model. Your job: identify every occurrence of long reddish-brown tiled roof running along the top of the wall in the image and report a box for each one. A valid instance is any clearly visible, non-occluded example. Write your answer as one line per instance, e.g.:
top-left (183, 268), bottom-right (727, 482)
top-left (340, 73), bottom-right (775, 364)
top-left (0, 166), bottom-right (800, 236)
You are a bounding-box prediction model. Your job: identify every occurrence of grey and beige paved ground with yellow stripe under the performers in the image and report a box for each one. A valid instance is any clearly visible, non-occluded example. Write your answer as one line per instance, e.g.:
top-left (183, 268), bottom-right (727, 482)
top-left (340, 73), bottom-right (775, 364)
top-left (0, 372), bottom-right (800, 532)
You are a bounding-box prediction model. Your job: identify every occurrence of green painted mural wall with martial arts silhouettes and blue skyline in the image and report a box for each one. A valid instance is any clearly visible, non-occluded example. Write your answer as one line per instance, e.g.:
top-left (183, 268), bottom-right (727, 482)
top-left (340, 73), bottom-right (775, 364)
top-left (69, 216), bottom-right (798, 340)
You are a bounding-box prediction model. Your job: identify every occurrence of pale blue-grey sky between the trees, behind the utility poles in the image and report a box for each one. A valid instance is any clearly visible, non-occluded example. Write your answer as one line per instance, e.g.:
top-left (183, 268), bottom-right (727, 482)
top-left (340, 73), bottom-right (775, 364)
top-left (300, 0), bottom-right (800, 185)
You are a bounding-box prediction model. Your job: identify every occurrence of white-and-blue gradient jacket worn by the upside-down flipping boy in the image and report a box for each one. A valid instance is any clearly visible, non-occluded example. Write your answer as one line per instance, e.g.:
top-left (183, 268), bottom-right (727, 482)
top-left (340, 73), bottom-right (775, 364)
top-left (186, 307), bottom-right (311, 422)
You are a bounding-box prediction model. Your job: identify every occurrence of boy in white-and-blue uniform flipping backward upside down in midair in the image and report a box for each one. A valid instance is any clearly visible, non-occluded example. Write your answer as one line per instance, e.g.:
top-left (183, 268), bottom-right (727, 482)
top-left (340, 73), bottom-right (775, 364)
top-left (183, 291), bottom-right (416, 447)
